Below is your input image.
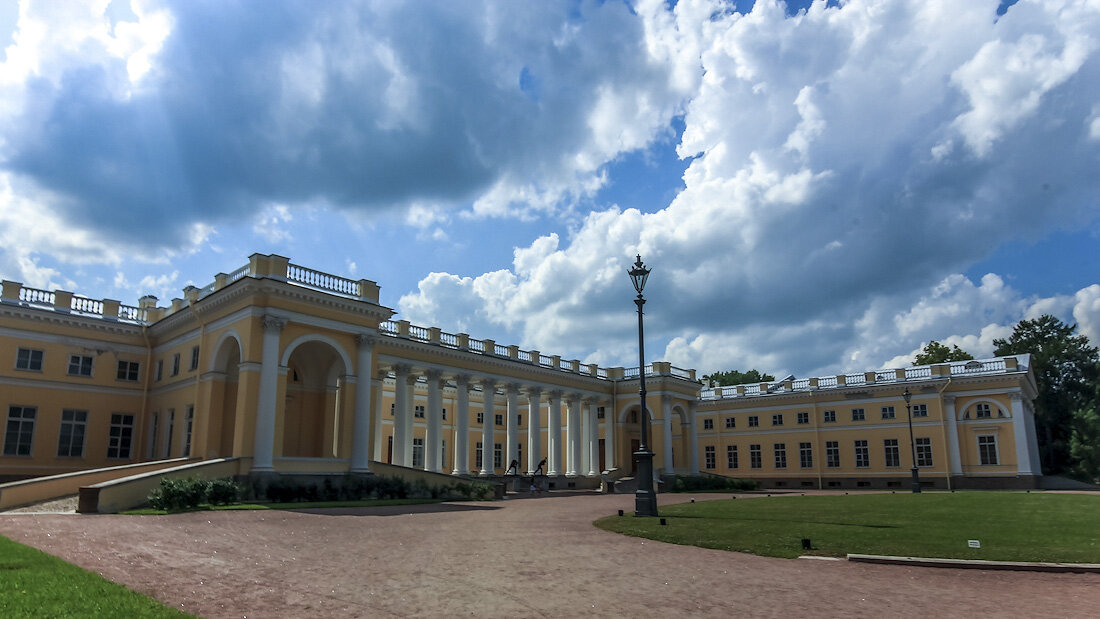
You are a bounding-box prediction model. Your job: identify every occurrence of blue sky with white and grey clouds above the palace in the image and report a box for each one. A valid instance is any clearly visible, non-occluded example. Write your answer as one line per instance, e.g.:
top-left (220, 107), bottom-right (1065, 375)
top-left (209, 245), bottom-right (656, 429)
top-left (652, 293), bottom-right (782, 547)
top-left (0, 0), bottom-right (1100, 376)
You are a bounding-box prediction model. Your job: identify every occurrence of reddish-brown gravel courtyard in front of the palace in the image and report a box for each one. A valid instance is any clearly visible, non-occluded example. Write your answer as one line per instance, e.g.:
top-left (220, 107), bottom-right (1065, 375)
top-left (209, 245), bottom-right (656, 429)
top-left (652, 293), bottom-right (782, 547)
top-left (0, 494), bottom-right (1100, 619)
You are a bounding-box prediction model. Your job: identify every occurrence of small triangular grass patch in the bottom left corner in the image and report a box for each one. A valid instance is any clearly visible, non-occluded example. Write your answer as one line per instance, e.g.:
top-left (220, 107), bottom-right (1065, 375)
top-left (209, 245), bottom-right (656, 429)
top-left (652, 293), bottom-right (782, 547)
top-left (0, 535), bottom-right (190, 617)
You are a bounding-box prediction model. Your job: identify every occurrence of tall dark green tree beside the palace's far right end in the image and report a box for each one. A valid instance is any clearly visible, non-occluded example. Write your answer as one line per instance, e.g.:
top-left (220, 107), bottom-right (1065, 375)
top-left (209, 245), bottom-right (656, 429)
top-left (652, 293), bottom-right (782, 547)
top-left (993, 314), bottom-right (1100, 474)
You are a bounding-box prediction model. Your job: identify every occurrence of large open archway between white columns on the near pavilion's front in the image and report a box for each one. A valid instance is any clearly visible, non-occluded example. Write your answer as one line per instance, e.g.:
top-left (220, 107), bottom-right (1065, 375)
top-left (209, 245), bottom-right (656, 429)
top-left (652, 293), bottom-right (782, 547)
top-left (276, 339), bottom-right (348, 457)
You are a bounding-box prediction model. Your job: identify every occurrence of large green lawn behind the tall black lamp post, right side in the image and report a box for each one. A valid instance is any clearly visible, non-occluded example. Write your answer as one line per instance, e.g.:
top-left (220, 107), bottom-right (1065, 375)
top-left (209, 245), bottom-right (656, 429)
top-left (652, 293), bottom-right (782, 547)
top-left (596, 491), bottom-right (1100, 563)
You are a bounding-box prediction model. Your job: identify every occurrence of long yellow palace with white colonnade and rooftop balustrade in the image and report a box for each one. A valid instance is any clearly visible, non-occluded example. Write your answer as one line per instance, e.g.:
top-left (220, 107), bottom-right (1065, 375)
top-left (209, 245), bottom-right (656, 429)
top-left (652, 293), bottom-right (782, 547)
top-left (0, 254), bottom-right (1041, 488)
